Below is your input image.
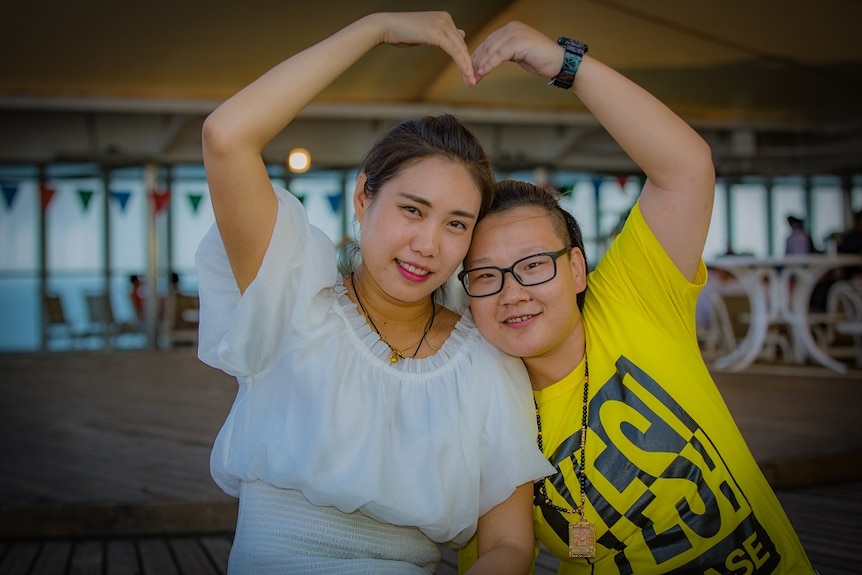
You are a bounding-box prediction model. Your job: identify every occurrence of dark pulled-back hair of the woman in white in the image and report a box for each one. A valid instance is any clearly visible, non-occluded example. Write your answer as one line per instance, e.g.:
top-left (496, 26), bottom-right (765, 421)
top-left (339, 114), bottom-right (495, 303)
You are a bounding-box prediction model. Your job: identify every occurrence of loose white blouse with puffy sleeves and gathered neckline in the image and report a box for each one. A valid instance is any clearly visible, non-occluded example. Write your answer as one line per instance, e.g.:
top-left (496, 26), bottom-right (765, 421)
top-left (196, 188), bottom-right (553, 543)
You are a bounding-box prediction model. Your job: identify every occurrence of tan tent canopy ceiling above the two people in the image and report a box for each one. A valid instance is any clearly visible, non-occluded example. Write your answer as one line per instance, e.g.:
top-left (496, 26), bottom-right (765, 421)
top-left (0, 0), bottom-right (862, 175)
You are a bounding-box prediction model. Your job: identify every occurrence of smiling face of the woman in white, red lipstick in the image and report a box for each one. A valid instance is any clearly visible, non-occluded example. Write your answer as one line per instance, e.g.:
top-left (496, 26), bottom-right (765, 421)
top-left (353, 157), bottom-right (481, 302)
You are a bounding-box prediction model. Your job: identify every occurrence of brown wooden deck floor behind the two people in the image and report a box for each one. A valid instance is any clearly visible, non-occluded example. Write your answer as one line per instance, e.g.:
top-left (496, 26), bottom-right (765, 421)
top-left (0, 349), bottom-right (862, 575)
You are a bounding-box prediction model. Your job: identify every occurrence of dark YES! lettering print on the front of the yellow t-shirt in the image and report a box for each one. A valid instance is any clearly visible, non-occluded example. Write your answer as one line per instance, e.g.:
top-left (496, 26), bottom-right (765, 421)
top-left (537, 357), bottom-right (781, 575)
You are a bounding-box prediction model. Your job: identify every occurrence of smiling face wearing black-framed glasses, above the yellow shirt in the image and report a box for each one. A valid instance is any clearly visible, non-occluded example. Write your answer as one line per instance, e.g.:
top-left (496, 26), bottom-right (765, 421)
top-left (465, 206), bottom-right (586, 366)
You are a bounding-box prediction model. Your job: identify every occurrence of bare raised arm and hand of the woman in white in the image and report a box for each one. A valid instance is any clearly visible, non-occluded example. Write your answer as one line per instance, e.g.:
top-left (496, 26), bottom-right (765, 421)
top-left (202, 12), bottom-right (475, 291)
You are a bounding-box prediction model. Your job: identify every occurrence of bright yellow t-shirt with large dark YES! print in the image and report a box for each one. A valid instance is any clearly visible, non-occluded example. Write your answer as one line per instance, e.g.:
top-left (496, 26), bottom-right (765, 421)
top-left (459, 205), bottom-right (814, 575)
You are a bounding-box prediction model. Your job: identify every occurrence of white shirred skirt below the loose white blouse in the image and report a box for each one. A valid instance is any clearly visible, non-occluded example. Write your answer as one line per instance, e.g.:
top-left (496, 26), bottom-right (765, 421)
top-left (228, 481), bottom-right (440, 575)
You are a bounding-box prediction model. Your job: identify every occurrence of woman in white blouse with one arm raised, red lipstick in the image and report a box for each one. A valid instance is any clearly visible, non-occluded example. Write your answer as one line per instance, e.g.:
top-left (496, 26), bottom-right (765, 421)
top-left (197, 12), bottom-right (552, 575)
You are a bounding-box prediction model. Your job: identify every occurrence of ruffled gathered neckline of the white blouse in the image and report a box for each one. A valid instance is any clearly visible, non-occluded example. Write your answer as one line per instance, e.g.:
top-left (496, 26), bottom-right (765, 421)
top-left (333, 274), bottom-right (479, 374)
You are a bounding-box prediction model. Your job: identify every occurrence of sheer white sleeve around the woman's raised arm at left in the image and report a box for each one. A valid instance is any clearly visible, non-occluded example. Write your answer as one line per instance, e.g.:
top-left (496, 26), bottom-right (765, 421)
top-left (195, 186), bottom-right (337, 378)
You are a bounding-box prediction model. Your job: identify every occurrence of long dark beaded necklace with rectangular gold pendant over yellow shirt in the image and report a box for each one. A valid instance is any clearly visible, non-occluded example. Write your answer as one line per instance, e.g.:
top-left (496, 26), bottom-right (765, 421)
top-left (533, 354), bottom-right (596, 557)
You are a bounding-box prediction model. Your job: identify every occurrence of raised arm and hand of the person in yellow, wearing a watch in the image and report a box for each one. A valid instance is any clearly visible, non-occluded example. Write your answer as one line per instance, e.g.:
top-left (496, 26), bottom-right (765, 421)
top-left (473, 22), bottom-right (715, 279)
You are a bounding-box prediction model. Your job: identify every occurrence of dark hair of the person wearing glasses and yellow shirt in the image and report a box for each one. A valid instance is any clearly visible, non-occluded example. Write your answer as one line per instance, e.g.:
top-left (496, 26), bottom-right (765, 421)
top-left (485, 180), bottom-right (589, 310)
